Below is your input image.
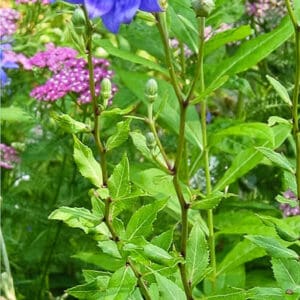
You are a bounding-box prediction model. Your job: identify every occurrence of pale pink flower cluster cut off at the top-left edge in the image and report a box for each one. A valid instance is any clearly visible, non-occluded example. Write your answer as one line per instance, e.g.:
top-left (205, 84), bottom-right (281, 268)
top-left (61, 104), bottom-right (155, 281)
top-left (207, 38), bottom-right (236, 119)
top-left (0, 8), bottom-right (20, 41)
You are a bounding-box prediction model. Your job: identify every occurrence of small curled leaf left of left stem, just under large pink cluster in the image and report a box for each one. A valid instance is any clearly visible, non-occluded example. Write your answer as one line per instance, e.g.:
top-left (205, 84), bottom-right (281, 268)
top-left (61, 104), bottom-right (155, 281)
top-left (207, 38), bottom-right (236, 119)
top-left (51, 112), bottom-right (92, 134)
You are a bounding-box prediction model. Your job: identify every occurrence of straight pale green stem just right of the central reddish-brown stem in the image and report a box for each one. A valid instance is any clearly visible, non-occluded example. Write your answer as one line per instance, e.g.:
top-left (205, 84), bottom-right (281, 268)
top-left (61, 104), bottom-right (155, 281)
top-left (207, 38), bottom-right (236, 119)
top-left (196, 17), bottom-right (217, 290)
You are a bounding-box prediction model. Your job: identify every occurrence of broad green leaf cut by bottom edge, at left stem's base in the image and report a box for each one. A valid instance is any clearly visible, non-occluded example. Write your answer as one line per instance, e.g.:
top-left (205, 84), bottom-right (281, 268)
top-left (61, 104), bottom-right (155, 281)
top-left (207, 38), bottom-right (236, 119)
top-left (104, 266), bottom-right (137, 300)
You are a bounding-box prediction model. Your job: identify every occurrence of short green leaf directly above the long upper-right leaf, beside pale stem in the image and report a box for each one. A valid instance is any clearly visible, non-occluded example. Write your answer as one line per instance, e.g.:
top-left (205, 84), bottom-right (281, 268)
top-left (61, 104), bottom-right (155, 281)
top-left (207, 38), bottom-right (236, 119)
top-left (204, 25), bottom-right (252, 55)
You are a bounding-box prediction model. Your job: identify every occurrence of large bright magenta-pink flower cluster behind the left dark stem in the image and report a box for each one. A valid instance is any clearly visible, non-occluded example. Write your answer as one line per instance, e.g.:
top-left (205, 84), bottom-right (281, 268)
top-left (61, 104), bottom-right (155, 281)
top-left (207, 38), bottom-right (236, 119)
top-left (29, 44), bottom-right (116, 104)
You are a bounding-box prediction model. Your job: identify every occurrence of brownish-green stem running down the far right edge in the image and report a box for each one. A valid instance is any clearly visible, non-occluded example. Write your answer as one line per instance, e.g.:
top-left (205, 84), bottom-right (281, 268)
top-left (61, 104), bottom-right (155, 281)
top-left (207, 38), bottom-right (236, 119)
top-left (285, 0), bottom-right (300, 201)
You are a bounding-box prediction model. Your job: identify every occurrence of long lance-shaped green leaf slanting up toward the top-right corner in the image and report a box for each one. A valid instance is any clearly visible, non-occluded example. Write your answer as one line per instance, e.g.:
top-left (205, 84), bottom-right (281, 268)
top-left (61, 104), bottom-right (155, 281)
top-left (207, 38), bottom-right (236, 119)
top-left (206, 18), bottom-right (293, 81)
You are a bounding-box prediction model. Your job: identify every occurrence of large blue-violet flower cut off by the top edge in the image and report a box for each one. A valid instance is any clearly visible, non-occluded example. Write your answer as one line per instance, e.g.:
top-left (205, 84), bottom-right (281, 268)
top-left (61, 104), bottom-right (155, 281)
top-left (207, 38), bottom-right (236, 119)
top-left (65, 0), bottom-right (162, 33)
